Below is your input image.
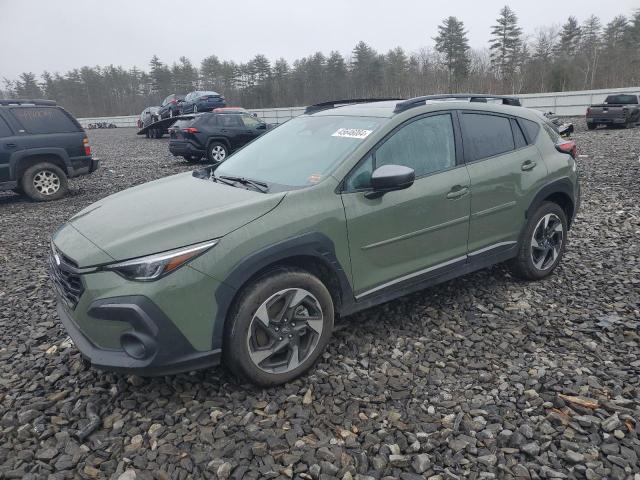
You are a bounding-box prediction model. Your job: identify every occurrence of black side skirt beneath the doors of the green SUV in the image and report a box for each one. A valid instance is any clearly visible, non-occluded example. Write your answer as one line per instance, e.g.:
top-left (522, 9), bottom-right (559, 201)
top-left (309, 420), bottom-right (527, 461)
top-left (340, 242), bottom-right (518, 316)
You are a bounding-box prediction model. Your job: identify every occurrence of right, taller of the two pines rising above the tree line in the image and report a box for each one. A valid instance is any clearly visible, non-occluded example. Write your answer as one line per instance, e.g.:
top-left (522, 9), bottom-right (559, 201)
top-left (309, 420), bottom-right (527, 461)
top-left (489, 5), bottom-right (522, 79)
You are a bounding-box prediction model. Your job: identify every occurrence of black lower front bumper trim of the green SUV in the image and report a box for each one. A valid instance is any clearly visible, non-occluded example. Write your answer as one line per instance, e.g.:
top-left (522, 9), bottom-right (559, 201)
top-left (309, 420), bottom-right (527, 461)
top-left (57, 295), bottom-right (221, 376)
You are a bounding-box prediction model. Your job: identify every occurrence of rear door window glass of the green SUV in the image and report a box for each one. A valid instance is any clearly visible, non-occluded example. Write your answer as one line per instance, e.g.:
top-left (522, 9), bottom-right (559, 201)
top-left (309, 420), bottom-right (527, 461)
top-left (461, 113), bottom-right (515, 160)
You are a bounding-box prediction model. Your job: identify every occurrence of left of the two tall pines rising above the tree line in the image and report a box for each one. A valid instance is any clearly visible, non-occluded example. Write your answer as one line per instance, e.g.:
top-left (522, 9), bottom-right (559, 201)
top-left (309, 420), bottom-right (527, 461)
top-left (434, 17), bottom-right (470, 90)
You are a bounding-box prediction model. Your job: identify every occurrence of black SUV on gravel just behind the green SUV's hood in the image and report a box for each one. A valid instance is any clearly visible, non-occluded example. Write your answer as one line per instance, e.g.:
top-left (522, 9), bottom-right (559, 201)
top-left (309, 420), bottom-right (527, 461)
top-left (169, 111), bottom-right (267, 162)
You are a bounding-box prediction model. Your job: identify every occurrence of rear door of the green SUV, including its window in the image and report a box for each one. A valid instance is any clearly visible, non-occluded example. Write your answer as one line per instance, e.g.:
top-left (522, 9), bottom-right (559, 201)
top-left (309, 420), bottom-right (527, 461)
top-left (460, 112), bottom-right (547, 256)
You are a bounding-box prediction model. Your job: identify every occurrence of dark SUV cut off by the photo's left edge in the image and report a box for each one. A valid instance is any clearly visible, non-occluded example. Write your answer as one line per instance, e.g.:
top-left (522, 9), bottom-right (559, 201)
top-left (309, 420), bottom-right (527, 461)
top-left (0, 100), bottom-right (99, 202)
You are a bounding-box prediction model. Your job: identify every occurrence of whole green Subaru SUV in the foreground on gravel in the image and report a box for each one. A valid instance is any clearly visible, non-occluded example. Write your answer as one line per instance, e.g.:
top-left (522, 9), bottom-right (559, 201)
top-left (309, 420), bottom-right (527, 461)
top-left (51, 95), bottom-right (580, 385)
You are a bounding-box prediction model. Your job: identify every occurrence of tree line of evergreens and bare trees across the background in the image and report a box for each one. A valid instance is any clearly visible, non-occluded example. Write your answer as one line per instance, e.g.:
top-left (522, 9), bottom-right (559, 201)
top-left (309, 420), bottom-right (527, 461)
top-left (0, 6), bottom-right (640, 117)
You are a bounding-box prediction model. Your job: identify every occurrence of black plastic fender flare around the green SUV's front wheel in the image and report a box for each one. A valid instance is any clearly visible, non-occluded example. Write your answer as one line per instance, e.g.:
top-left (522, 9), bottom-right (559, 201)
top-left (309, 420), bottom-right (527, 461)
top-left (212, 232), bottom-right (355, 349)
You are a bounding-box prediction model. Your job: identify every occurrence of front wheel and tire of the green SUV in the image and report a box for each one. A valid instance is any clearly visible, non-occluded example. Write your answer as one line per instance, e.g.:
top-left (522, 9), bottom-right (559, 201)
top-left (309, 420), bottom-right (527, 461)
top-left (222, 267), bottom-right (334, 387)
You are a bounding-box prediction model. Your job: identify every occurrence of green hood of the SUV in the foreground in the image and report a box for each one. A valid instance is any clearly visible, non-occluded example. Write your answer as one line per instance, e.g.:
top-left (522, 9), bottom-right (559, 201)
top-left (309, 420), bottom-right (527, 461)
top-left (59, 172), bottom-right (285, 266)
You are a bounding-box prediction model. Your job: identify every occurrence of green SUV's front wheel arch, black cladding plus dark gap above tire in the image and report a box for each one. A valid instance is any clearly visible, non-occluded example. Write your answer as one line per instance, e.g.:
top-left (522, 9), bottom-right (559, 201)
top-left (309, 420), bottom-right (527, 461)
top-left (212, 233), bottom-right (354, 348)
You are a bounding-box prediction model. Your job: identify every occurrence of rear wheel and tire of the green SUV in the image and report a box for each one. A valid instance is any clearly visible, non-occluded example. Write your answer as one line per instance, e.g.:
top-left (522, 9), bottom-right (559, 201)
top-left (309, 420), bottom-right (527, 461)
top-left (510, 202), bottom-right (567, 280)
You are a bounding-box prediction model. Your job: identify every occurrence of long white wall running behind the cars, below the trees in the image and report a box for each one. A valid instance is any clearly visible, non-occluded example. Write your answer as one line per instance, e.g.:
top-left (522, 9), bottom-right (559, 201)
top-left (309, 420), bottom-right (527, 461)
top-left (78, 87), bottom-right (640, 128)
